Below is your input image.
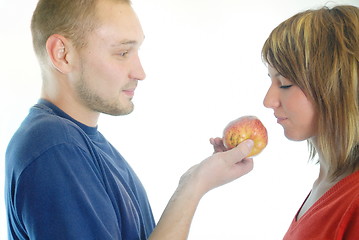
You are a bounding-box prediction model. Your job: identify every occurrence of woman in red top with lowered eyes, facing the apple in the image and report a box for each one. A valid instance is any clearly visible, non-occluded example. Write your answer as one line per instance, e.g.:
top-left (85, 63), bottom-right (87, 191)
top-left (211, 6), bottom-right (359, 240)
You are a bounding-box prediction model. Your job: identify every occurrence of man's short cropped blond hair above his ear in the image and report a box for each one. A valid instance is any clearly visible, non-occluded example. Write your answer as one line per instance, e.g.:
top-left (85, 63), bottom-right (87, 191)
top-left (31, 0), bottom-right (131, 58)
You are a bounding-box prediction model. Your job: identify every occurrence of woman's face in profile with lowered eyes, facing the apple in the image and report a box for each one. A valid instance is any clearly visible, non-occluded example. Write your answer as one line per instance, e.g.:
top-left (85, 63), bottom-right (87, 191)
top-left (263, 65), bottom-right (317, 141)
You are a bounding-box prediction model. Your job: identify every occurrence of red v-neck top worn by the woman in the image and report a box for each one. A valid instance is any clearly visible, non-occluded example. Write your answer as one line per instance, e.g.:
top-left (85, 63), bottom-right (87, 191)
top-left (283, 171), bottom-right (359, 240)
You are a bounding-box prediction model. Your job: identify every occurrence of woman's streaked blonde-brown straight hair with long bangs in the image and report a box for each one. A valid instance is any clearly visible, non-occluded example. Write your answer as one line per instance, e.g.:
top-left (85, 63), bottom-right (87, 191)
top-left (262, 5), bottom-right (359, 179)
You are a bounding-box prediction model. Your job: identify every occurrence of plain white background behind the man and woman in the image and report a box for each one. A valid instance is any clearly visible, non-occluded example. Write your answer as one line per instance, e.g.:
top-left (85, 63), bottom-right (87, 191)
top-left (0, 0), bottom-right (359, 240)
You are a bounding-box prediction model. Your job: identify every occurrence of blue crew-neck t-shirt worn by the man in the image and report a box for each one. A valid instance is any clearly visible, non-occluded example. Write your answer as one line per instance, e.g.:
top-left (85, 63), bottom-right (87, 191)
top-left (5, 100), bottom-right (155, 240)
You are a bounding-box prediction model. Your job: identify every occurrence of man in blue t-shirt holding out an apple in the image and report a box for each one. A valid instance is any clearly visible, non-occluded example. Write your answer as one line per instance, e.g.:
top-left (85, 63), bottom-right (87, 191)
top-left (5, 0), bottom-right (253, 240)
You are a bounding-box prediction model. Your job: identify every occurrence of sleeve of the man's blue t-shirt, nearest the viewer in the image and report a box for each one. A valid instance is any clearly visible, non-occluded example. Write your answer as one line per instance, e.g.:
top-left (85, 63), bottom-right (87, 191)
top-left (14, 143), bottom-right (121, 240)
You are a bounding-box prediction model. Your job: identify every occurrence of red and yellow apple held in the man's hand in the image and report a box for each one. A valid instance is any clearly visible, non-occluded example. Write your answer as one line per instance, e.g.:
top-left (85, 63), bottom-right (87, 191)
top-left (223, 116), bottom-right (268, 157)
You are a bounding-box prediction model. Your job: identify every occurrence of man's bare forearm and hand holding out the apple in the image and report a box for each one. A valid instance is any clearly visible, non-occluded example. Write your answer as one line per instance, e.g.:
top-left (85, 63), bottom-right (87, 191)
top-left (149, 140), bottom-right (253, 240)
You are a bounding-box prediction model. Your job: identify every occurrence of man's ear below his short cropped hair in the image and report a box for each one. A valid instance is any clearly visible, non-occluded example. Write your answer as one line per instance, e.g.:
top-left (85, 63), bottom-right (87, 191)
top-left (46, 34), bottom-right (70, 73)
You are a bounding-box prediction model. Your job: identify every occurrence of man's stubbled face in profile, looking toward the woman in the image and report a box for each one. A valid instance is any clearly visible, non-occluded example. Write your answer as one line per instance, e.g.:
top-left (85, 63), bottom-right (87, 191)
top-left (71, 1), bottom-right (145, 115)
